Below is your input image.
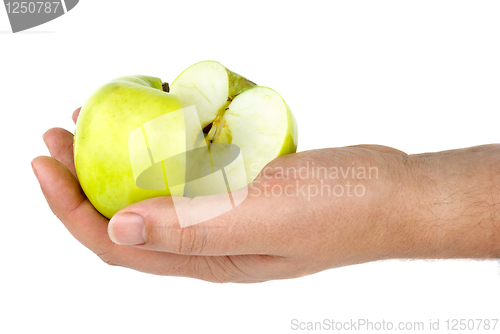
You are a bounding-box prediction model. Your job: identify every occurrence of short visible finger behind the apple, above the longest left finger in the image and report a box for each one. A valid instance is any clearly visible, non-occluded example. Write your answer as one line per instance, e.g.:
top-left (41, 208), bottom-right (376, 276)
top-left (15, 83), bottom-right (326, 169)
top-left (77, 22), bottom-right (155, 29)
top-left (43, 128), bottom-right (77, 178)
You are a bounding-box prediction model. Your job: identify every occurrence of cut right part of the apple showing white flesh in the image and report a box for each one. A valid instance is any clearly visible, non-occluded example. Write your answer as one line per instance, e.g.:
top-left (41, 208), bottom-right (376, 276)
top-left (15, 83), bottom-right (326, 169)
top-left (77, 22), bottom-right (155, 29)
top-left (170, 61), bottom-right (298, 183)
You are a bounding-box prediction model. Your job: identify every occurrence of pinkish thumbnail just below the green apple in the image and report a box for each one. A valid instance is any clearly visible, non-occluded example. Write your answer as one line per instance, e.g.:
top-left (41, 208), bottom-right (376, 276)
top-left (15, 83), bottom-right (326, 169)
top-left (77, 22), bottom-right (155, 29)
top-left (108, 213), bottom-right (146, 245)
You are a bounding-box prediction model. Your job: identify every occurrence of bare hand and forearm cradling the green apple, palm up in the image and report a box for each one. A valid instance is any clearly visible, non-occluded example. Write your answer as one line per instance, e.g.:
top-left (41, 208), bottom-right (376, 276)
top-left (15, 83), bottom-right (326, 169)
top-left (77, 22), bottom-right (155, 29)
top-left (32, 109), bottom-right (500, 282)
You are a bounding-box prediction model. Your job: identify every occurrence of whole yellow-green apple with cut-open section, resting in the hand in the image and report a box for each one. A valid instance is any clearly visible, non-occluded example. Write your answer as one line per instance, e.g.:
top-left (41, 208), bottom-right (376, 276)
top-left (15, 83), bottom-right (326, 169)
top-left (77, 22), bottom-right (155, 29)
top-left (74, 61), bottom-right (297, 218)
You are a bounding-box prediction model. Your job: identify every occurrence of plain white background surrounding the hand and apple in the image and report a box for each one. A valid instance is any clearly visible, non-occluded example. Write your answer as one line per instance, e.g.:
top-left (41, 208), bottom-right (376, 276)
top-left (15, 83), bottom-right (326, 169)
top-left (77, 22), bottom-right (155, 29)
top-left (0, 0), bottom-right (500, 333)
